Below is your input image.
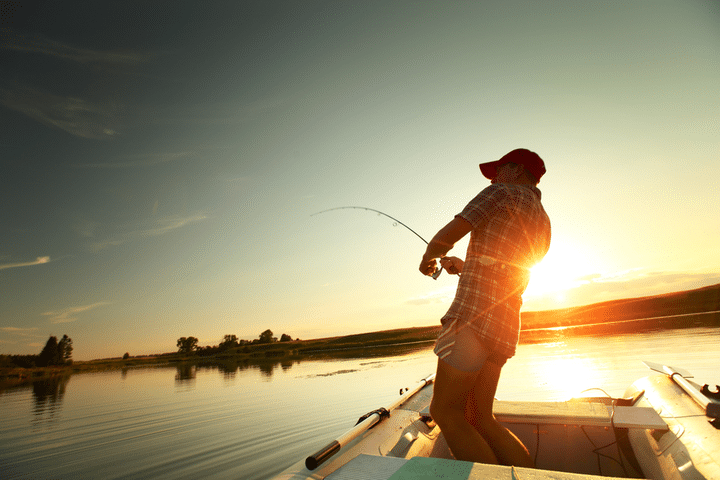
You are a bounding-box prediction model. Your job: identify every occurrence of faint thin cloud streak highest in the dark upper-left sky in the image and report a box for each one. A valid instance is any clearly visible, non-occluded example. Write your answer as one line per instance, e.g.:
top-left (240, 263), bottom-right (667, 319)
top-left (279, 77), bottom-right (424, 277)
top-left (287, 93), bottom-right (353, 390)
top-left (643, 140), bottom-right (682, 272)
top-left (0, 28), bottom-right (152, 66)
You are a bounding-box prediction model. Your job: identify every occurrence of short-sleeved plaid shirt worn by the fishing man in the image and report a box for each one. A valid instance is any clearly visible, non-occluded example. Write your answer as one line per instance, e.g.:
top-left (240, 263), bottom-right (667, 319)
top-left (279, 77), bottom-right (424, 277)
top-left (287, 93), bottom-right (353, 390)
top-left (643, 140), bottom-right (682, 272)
top-left (441, 183), bottom-right (550, 358)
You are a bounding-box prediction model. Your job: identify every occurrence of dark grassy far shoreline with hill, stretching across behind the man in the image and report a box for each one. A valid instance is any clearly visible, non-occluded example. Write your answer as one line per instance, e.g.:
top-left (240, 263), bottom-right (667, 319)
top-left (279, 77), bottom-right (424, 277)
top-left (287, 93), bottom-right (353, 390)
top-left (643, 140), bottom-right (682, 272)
top-left (0, 284), bottom-right (720, 392)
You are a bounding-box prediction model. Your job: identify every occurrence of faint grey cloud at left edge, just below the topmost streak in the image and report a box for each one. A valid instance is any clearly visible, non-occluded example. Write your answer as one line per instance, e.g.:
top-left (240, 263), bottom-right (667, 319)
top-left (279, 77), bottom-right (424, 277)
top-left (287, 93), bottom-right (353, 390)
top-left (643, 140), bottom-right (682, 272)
top-left (0, 84), bottom-right (123, 139)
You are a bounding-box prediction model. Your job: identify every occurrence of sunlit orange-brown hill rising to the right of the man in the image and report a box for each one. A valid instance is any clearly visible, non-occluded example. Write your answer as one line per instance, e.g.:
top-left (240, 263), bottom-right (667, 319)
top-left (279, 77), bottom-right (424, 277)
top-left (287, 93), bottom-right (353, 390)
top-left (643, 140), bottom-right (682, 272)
top-left (522, 284), bottom-right (720, 330)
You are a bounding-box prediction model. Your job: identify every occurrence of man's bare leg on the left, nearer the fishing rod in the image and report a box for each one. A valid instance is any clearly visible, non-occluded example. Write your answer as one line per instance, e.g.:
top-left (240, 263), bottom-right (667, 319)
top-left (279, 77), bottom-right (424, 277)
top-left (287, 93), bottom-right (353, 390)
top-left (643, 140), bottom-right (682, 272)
top-left (430, 359), bottom-right (498, 464)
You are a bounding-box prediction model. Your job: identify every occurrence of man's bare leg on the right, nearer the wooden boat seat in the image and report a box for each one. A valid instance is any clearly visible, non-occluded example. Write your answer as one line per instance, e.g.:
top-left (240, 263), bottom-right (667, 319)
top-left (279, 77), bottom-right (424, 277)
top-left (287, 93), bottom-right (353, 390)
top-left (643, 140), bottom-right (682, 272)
top-left (466, 361), bottom-right (535, 468)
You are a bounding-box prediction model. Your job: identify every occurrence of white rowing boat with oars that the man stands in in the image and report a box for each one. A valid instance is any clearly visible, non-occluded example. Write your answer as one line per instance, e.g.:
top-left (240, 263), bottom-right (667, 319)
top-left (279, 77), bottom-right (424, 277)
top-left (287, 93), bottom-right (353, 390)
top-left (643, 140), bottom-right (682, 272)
top-left (274, 362), bottom-right (720, 480)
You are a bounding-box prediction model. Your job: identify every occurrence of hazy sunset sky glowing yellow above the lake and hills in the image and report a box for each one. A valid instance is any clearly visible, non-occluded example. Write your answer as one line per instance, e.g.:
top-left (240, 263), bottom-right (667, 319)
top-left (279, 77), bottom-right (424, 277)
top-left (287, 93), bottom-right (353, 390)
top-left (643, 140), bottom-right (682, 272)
top-left (0, 0), bottom-right (720, 360)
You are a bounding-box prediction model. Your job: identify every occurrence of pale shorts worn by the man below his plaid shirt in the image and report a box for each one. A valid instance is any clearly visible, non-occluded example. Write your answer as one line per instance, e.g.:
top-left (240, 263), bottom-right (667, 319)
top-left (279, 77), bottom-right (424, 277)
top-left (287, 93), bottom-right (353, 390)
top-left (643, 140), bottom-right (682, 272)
top-left (433, 322), bottom-right (508, 372)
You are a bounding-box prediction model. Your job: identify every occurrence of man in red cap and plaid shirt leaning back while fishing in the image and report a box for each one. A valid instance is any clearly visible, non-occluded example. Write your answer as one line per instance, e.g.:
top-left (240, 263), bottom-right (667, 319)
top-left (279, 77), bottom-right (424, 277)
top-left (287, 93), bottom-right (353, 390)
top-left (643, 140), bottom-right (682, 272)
top-left (420, 149), bottom-right (550, 467)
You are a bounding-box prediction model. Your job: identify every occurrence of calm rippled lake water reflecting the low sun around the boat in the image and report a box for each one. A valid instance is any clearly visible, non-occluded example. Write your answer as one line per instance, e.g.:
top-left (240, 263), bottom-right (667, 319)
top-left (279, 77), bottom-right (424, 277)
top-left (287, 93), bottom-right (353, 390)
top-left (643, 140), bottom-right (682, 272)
top-left (0, 327), bottom-right (720, 479)
